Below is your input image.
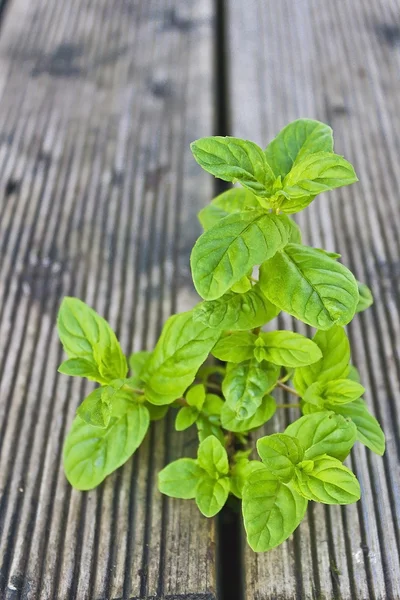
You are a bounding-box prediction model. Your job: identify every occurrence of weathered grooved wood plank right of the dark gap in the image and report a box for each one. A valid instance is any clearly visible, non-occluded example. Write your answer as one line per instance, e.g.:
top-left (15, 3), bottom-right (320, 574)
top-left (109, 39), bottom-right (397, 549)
top-left (227, 0), bottom-right (400, 600)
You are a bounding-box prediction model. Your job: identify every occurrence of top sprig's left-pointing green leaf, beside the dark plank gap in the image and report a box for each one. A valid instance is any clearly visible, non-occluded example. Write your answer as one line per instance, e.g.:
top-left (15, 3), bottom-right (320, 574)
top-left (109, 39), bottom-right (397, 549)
top-left (190, 136), bottom-right (275, 198)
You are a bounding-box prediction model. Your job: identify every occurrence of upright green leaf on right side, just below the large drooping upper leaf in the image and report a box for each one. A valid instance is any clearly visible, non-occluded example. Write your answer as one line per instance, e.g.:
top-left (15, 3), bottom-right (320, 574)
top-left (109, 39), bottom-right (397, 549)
top-left (293, 326), bottom-right (350, 395)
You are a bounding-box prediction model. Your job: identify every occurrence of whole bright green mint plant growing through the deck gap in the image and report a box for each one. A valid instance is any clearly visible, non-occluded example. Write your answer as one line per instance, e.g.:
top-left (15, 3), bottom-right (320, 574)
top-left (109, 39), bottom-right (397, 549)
top-left (58, 119), bottom-right (385, 552)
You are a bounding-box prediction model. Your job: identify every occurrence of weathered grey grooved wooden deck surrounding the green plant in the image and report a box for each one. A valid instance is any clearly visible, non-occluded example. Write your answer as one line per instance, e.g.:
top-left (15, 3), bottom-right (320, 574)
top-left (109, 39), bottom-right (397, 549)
top-left (0, 0), bottom-right (400, 600)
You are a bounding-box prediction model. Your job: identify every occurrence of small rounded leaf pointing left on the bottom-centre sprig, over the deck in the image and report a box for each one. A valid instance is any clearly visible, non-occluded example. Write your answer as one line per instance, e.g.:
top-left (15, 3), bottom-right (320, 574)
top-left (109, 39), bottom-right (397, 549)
top-left (158, 458), bottom-right (205, 500)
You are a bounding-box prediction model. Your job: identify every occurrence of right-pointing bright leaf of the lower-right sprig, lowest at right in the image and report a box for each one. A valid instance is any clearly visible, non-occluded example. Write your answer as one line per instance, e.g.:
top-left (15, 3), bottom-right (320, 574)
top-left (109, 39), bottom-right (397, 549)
top-left (295, 454), bottom-right (361, 504)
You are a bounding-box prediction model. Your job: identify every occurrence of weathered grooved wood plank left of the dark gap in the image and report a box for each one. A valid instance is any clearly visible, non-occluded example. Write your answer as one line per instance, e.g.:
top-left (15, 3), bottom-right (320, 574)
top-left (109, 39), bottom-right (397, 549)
top-left (0, 0), bottom-right (216, 600)
